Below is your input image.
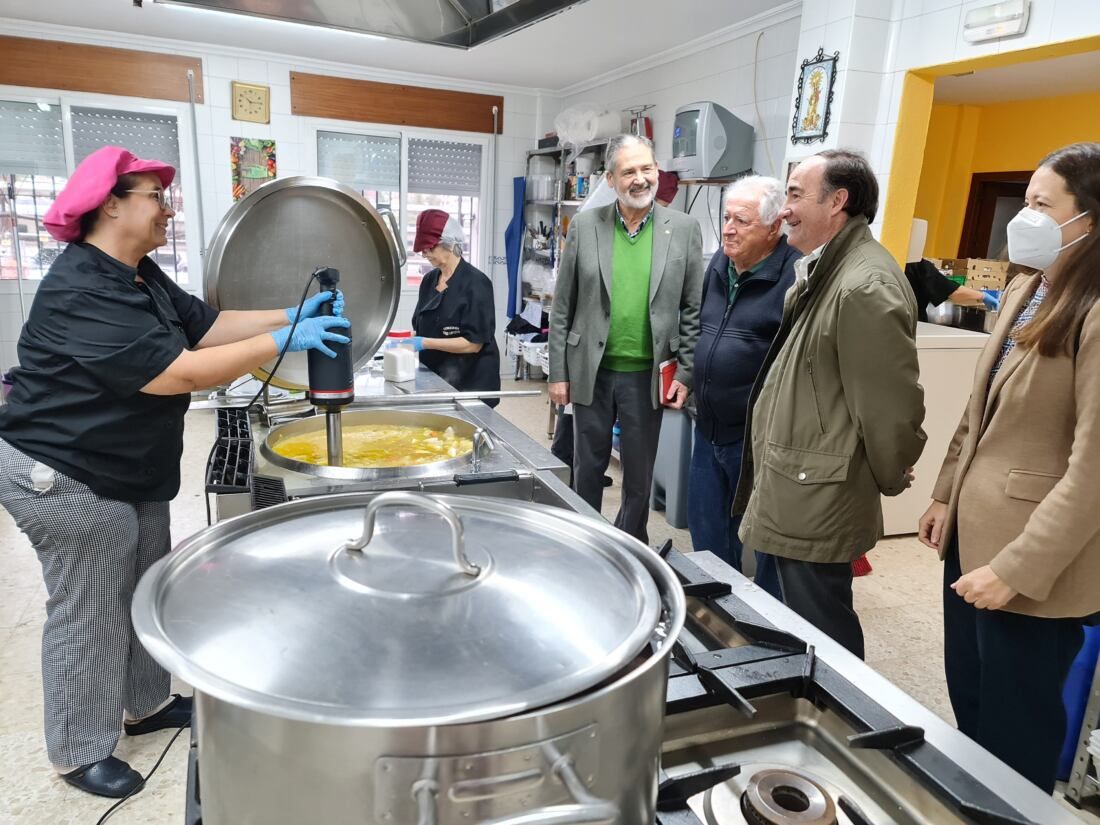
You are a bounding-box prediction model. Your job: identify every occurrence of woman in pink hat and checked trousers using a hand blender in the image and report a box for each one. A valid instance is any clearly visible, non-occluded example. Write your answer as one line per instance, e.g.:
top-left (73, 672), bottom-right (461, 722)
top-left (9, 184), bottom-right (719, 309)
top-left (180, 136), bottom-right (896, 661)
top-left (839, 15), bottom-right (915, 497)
top-left (0, 146), bottom-right (349, 796)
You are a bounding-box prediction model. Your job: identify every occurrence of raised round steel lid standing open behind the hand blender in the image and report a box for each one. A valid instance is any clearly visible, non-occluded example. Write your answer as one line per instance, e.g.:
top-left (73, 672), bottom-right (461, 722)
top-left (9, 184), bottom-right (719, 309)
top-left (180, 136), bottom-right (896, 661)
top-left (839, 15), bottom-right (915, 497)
top-left (205, 177), bottom-right (405, 389)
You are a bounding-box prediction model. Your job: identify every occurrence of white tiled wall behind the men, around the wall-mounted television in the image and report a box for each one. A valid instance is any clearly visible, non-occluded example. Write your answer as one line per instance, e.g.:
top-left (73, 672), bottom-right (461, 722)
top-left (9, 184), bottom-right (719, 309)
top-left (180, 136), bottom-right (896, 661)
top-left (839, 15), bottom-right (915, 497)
top-left (554, 0), bottom-right (805, 257)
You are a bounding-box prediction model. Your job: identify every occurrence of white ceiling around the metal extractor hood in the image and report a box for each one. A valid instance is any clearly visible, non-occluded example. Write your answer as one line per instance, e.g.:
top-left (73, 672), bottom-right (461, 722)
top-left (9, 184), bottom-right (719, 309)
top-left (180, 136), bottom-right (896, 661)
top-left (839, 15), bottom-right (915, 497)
top-left (0, 0), bottom-right (788, 90)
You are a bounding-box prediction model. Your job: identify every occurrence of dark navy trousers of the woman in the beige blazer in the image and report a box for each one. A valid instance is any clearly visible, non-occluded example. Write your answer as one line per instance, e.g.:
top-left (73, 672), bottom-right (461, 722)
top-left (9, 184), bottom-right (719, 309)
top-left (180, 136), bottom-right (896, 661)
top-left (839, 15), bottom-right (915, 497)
top-left (944, 541), bottom-right (1085, 793)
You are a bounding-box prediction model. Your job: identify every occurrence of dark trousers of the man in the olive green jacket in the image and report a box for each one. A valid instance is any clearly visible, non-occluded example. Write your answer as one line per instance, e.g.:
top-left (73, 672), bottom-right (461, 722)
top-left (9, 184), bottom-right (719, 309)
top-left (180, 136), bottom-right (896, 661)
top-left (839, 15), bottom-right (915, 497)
top-left (754, 553), bottom-right (864, 659)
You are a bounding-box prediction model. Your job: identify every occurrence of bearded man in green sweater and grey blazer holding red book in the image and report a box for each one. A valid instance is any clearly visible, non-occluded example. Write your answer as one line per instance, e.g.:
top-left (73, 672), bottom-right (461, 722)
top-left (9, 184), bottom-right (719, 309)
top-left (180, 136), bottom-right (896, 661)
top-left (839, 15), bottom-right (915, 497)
top-left (550, 134), bottom-right (703, 541)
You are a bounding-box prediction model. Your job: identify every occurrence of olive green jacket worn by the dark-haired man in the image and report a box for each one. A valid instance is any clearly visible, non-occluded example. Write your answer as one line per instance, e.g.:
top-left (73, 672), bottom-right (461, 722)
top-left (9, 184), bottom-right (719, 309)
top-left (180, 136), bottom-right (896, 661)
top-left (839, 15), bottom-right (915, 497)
top-left (734, 218), bottom-right (925, 562)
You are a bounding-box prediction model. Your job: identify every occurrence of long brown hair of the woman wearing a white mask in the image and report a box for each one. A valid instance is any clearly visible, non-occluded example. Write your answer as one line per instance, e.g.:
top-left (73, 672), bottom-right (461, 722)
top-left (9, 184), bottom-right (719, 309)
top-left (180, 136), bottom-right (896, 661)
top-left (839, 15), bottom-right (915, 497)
top-left (1016, 143), bottom-right (1100, 358)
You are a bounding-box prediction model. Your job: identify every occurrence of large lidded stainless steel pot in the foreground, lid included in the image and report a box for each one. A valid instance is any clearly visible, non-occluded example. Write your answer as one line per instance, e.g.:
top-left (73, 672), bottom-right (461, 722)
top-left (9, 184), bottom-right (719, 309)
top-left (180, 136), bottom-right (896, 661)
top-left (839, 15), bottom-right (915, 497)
top-left (133, 493), bottom-right (684, 825)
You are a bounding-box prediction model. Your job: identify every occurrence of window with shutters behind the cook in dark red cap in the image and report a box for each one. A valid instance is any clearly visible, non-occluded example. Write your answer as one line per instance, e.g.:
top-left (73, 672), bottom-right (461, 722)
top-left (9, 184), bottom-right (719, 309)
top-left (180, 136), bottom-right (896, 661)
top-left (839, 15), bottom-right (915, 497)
top-left (317, 131), bottom-right (482, 288)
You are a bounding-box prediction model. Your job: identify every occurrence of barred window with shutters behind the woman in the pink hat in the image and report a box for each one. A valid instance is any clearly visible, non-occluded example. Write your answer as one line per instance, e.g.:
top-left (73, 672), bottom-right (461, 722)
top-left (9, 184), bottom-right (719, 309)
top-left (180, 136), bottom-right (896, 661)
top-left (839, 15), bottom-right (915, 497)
top-left (0, 100), bottom-right (188, 284)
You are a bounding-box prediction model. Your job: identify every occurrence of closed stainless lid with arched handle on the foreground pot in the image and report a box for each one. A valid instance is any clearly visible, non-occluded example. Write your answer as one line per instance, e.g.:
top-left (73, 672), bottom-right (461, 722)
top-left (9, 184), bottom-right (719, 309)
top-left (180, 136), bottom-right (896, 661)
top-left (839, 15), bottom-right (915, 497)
top-left (133, 493), bottom-right (660, 726)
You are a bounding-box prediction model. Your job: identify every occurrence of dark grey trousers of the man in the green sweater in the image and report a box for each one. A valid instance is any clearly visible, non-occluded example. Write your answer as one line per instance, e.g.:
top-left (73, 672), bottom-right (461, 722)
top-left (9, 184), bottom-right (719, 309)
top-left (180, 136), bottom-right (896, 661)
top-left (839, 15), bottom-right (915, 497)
top-left (573, 370), bottom-right (663, 542)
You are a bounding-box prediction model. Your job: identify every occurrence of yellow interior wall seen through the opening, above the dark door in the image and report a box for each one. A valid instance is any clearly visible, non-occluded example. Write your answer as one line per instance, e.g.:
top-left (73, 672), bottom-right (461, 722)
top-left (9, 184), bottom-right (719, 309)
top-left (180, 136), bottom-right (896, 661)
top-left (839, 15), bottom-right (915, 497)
top-left (913, 92), bottom-right (1100, 257)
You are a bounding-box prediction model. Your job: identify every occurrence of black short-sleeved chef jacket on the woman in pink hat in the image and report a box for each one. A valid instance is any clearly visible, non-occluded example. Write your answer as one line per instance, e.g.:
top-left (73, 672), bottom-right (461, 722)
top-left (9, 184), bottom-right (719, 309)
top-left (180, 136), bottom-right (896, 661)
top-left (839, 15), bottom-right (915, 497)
top-left (0, 243), bottom-right (218, 502)
